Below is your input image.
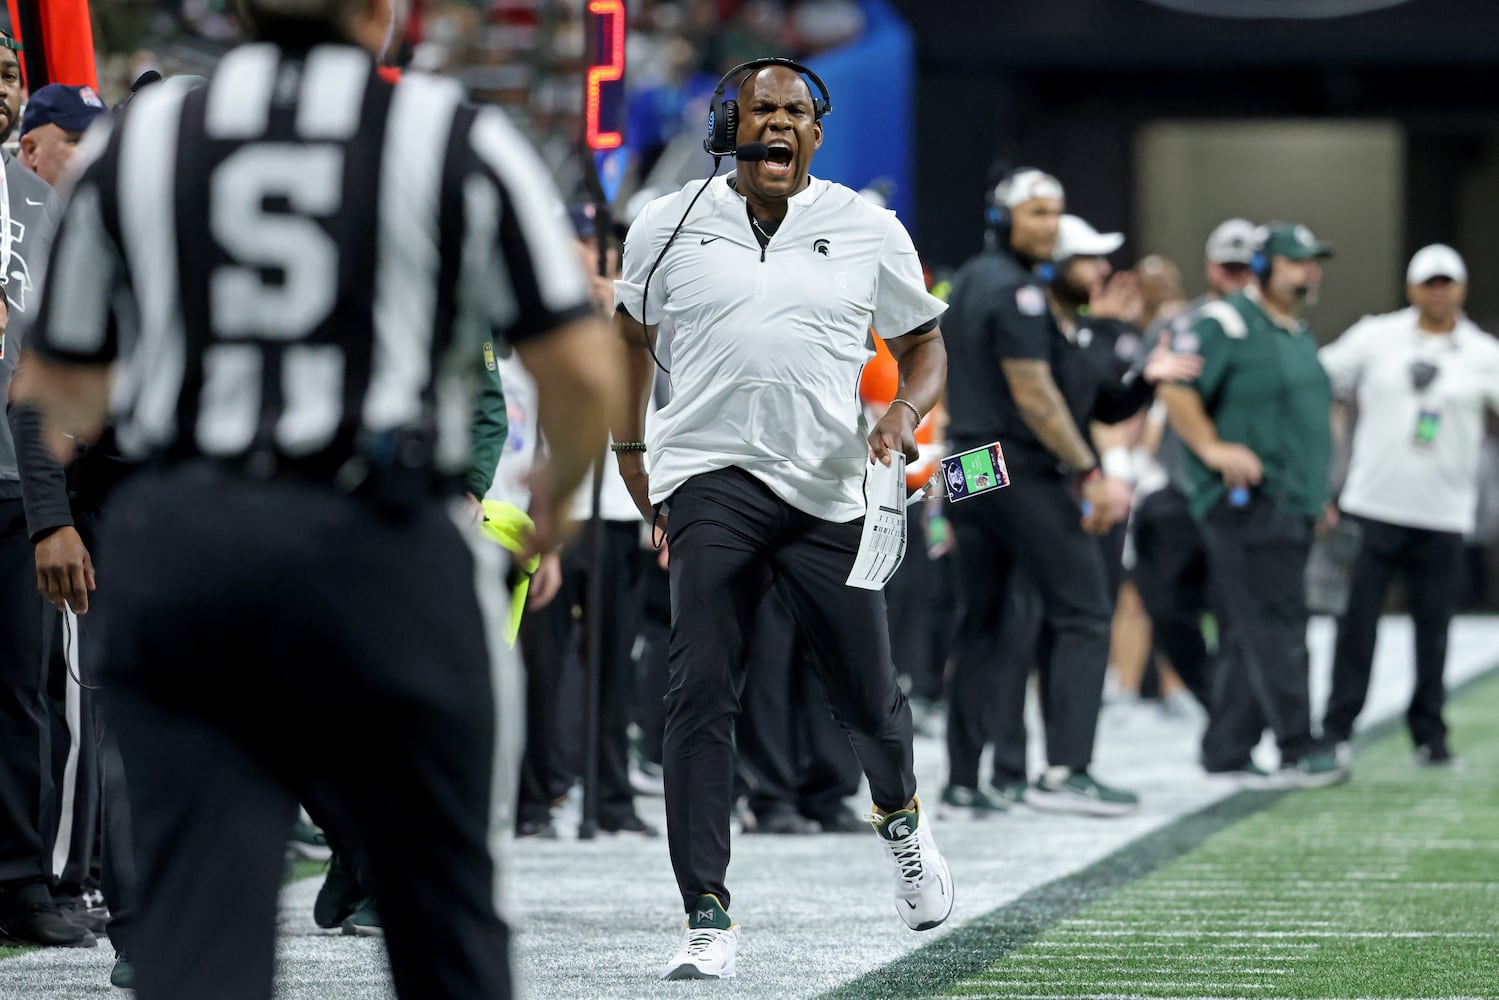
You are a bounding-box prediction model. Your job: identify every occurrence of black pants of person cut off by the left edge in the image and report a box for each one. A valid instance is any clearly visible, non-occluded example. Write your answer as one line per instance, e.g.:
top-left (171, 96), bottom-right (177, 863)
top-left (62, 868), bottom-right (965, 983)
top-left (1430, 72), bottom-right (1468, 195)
top-left (0, 498), bottom-right (52, 883)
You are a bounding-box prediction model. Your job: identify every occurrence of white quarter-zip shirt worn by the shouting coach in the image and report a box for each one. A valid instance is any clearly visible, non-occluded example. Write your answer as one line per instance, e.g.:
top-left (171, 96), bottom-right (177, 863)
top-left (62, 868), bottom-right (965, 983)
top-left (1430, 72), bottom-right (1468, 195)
top-left (615, 177), bottom-right (947, 522)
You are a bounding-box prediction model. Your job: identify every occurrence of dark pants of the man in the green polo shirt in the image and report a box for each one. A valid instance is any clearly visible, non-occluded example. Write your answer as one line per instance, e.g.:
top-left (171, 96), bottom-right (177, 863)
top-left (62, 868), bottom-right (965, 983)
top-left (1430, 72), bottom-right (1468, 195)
top-left (1202, 495), bottom-right (1318, 771)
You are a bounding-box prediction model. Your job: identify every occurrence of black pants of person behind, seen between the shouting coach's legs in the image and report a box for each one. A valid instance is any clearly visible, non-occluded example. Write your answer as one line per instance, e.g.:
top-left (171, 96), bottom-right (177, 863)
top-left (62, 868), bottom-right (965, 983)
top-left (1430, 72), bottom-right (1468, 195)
top-left (736, 592), bottom-right (859, 822)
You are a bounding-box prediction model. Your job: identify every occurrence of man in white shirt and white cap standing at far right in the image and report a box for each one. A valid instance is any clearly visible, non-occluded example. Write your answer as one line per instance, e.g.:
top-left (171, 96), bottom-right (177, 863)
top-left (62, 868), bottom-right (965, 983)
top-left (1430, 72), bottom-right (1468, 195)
top-left (1321, 244), bottom-right (1499, 765)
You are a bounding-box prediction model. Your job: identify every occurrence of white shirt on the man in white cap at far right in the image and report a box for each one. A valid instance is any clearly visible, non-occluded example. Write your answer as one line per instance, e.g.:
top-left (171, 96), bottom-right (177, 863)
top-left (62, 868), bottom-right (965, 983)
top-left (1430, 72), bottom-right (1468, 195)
top-left (1319, 307), bottom-right (1499, 532)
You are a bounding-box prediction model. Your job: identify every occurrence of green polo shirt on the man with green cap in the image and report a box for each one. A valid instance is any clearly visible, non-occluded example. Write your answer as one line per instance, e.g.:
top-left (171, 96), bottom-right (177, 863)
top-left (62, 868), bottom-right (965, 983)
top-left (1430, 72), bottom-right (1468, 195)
top-left (1175, 291), bottom-right (1333, 520)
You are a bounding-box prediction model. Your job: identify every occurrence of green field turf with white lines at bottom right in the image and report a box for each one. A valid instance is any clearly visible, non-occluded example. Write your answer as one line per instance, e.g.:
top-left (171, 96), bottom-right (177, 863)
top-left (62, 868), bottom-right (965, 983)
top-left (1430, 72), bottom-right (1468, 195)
top-left (923, 679), bottom-right (1499, 999)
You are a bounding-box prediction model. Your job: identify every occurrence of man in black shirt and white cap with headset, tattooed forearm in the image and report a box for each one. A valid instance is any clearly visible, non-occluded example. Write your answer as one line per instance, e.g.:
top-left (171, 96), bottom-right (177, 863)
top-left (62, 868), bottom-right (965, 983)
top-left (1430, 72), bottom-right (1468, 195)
top-left (944, 168), bottom-right (1195, 816)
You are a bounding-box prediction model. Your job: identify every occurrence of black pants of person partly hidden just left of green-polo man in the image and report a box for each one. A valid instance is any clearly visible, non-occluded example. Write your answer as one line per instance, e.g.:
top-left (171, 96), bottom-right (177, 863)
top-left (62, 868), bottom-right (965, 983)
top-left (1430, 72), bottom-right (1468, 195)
top-left (1130, 486), bottom-right (1211, 708)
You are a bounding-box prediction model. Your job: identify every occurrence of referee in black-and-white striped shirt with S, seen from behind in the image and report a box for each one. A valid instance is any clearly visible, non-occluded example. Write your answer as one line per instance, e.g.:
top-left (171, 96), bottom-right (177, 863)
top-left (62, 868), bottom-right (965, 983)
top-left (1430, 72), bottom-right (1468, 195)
top-left (19, 0), bottom-right (624, 1000)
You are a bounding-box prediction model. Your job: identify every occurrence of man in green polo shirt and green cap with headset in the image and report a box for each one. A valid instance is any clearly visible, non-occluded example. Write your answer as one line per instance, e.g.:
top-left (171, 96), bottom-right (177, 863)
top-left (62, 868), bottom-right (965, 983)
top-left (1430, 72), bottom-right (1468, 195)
top-left (1160, 222), bottom-right (1348, 787)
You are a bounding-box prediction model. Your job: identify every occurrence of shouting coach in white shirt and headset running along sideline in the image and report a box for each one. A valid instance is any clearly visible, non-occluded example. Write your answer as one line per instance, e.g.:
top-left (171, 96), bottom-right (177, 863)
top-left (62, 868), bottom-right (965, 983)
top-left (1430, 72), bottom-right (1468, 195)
top-left (615, 60), bottom-right (953, 979)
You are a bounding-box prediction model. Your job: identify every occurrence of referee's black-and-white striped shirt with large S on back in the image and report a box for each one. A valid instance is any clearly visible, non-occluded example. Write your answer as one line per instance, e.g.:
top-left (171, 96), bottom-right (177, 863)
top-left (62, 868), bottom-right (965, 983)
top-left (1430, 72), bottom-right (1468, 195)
top-left (30, 43), bottom-right (588, 485)
